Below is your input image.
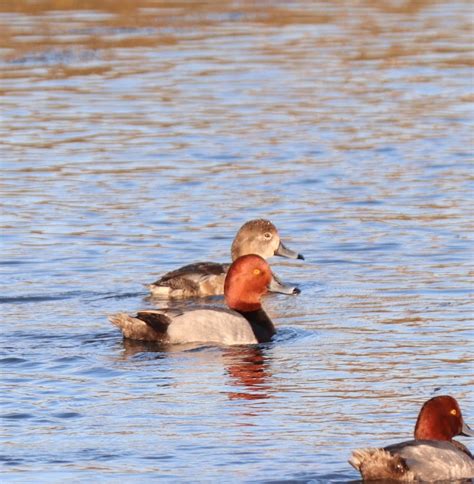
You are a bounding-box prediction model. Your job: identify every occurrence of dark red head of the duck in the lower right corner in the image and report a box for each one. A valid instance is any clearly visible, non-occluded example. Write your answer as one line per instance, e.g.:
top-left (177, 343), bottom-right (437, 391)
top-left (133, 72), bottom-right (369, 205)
top-left (415, 395), bottom-right (474, 441)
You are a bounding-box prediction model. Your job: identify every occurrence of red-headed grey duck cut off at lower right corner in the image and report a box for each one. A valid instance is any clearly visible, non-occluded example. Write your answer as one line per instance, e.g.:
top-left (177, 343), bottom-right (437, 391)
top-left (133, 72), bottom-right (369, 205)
top-left (349, 395), bottom-right (474, 482)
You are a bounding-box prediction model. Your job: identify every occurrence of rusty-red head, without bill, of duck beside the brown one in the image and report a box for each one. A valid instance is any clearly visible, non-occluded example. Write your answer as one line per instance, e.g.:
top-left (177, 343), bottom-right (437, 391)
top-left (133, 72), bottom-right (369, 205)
top-left (224, 254), bottom-right (273, 312)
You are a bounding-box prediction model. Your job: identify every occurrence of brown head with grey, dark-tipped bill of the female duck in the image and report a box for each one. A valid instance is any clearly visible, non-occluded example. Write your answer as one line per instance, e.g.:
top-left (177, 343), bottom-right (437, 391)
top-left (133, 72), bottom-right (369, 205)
top-left (231, 219), bottom-right (304, 260)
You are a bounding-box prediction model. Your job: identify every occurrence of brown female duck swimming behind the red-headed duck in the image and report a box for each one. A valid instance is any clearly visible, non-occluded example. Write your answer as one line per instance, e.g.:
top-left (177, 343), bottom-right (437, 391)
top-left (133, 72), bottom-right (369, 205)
top-left (148, 219), bottom-right (304, 298)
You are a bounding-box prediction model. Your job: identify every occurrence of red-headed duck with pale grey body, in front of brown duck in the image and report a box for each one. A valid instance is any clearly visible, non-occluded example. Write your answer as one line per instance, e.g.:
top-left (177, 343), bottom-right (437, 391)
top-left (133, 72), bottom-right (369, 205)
top-left (109, 254), bottom-right (282, 345)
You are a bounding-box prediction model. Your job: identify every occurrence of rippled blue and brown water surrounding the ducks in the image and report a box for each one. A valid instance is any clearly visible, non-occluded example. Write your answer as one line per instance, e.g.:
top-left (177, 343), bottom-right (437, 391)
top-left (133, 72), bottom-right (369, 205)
top-left (0, 0), bottom-right (474, 482)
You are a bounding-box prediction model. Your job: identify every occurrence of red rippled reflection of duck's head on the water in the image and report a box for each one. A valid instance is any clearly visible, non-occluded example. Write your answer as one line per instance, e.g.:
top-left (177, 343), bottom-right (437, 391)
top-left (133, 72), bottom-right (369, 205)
top-left (222, 346), bottom-right (271, 400)
